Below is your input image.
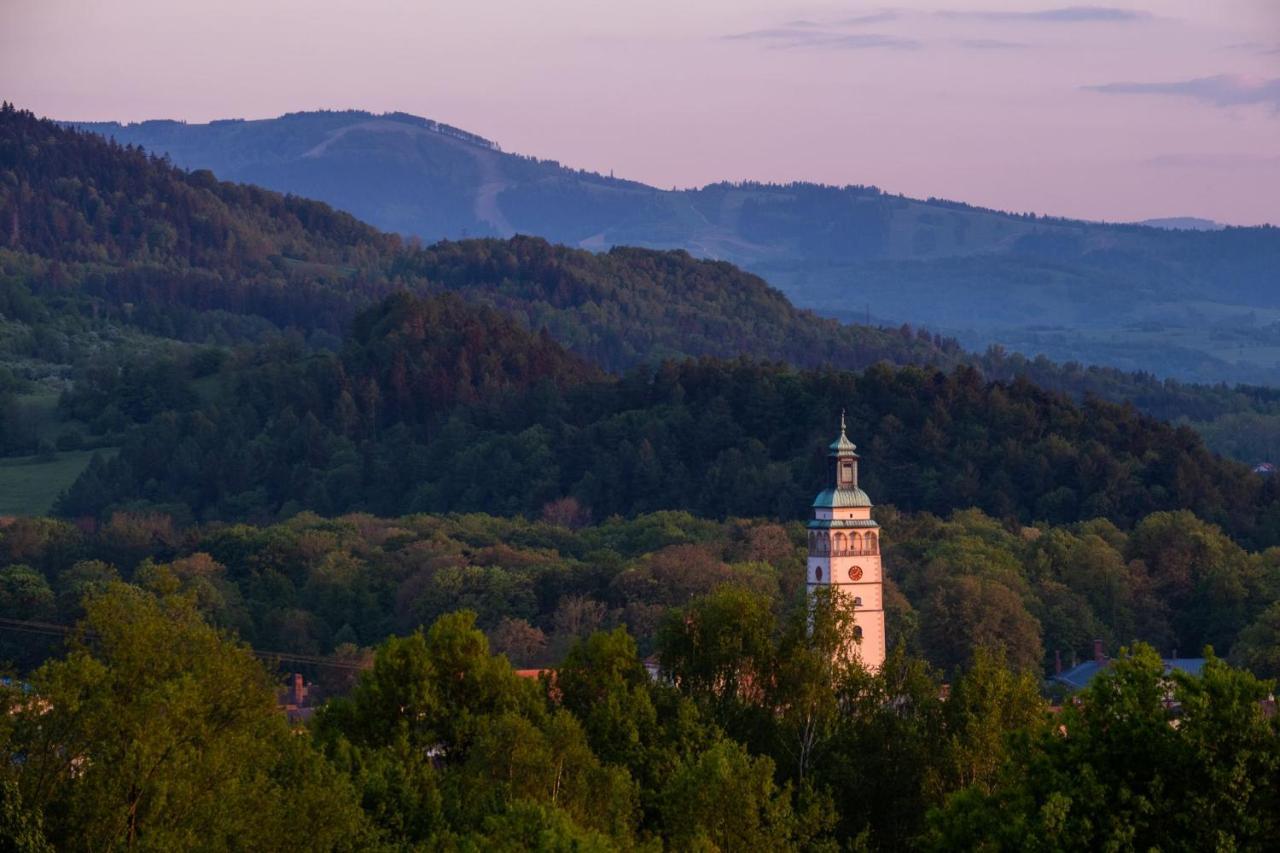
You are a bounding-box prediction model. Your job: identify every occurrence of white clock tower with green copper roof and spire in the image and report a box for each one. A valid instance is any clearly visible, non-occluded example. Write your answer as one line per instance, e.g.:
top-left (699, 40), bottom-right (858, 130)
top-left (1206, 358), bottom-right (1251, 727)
top-left (809, 412), bottom-right (884, 672)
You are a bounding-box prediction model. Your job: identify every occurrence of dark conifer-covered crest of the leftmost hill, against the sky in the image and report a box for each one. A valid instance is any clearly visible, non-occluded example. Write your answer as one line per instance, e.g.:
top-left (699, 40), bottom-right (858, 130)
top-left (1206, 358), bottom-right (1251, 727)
top-left (0, 109), bottom-right (399, 268)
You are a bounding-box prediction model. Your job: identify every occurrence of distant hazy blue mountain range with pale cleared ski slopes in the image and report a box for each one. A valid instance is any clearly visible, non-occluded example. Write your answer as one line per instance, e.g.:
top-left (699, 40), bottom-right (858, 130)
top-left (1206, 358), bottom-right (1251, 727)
top-left (72, 110), bottom-right (1280, 384)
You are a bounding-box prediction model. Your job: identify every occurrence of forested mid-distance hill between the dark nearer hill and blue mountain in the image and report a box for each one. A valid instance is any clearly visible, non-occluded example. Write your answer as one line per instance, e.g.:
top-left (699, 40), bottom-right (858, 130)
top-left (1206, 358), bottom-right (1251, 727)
top-left (393, 237), bottom-right (965, 370)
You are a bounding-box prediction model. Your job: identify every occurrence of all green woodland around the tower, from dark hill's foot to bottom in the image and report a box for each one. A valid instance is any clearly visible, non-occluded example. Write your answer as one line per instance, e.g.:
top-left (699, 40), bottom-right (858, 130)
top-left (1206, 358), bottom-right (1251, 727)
top-left (0, 484), bottom-right (1280, 850)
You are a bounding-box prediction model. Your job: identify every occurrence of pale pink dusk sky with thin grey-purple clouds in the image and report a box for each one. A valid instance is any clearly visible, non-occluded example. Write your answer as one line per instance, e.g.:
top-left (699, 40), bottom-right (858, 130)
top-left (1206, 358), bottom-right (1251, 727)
top-left (0, 0), bottom-right (1280, 224)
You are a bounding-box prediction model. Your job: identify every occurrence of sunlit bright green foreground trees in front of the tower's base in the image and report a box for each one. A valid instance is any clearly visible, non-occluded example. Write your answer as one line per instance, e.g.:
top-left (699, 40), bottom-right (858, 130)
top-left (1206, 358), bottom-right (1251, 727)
top-left (0, 566), bottom-right (1280, 852)
